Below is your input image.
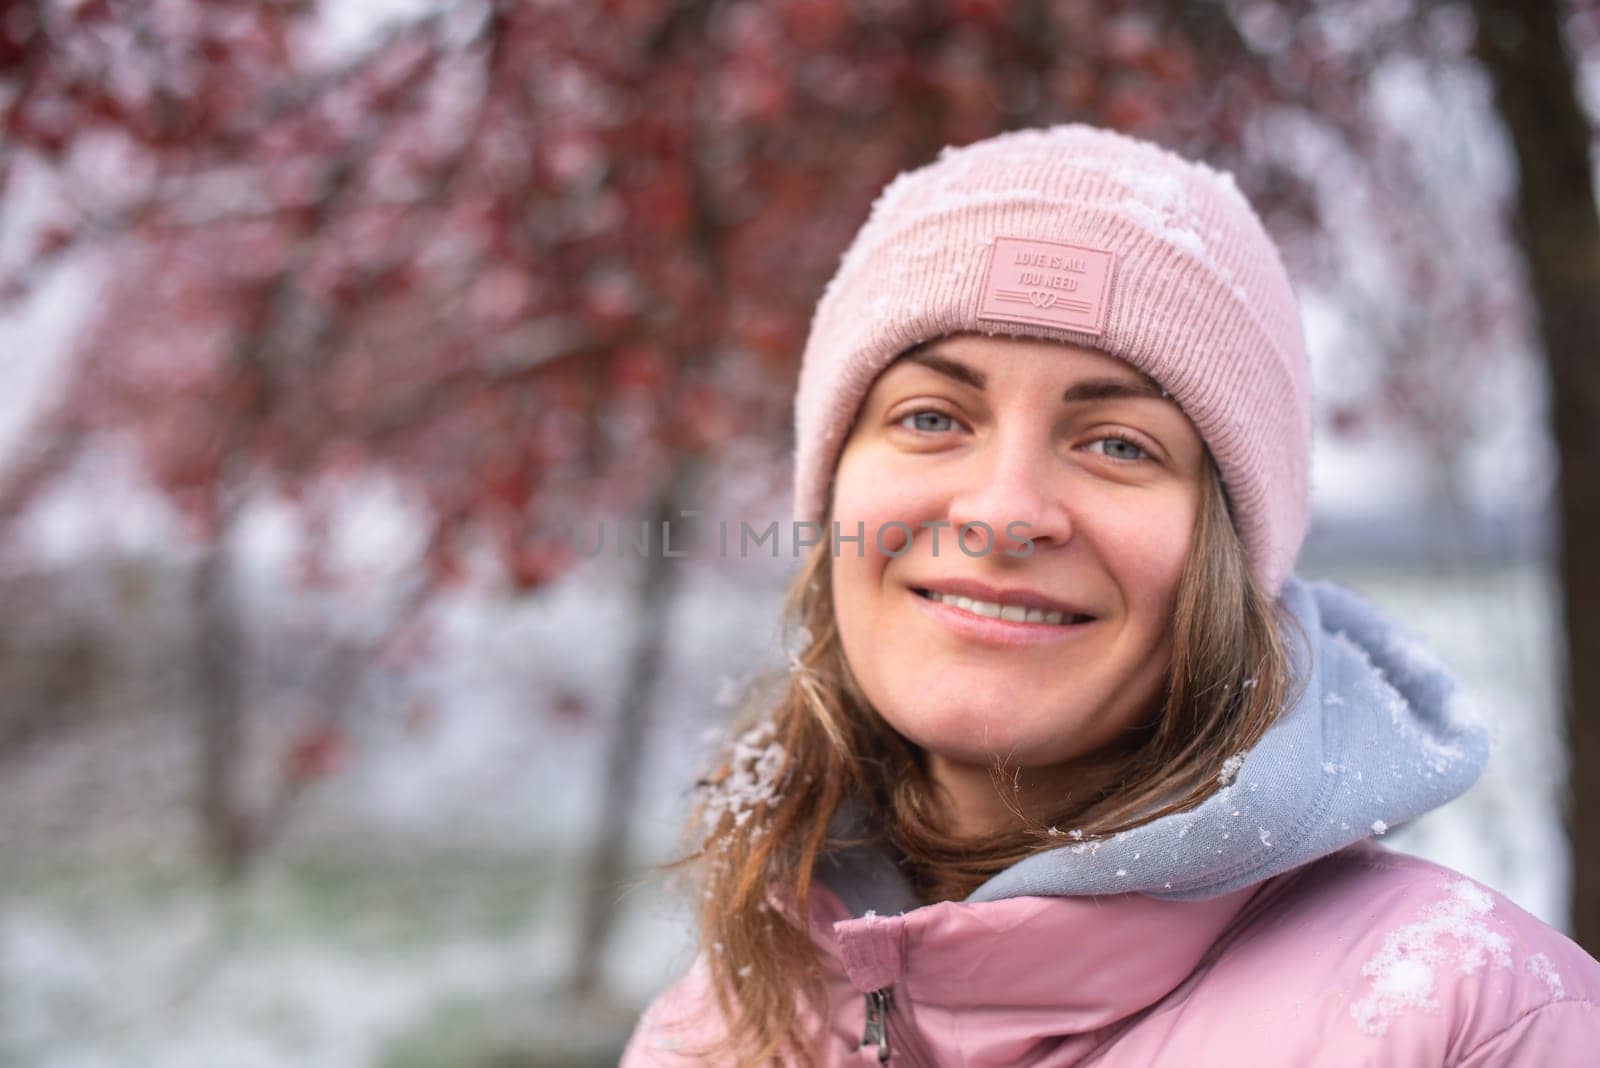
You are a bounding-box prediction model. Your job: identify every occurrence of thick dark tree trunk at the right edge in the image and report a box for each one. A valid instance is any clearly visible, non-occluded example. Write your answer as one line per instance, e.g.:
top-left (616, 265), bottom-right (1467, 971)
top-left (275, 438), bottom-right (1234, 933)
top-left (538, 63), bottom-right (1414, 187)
top-left (1472, 0), bottom-right (1600, 954)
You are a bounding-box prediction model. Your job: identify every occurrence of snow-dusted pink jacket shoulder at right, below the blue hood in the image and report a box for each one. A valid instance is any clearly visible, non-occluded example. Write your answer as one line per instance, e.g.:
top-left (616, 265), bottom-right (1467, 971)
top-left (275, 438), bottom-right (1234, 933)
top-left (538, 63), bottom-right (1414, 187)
top-left (1090, 843), bottom-right (1600, 1068)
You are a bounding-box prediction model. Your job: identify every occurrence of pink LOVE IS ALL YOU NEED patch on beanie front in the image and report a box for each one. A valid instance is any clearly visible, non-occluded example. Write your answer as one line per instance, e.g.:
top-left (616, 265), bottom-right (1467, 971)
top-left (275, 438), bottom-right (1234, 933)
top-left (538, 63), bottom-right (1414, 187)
top-left (978, 237), bottom-right (1115, 336)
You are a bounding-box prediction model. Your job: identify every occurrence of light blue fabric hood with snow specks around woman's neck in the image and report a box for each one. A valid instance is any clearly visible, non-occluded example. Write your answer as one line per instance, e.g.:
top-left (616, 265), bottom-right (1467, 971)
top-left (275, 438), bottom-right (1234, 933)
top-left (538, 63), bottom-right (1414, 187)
top-left (819, 576), bottom-right (1490, 916)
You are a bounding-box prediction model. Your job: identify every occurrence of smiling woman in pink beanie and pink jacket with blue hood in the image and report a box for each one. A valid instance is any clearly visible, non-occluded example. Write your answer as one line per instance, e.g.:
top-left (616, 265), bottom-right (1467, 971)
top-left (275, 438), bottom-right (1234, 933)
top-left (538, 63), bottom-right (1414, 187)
top-left (622, 125), bottom-right (1600, 1066)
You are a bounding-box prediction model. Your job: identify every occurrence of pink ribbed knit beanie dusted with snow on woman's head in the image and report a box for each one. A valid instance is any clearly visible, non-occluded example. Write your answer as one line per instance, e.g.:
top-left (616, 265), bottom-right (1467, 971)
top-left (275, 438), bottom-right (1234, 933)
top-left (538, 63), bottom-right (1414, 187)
top-left (795, 123), bottom-right (1310, 598)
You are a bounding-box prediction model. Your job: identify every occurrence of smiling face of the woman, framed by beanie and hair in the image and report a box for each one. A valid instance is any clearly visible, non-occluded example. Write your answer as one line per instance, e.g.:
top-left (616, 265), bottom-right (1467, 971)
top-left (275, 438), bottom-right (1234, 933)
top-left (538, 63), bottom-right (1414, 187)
top-left (830, 334), bottom-right (1205, 824)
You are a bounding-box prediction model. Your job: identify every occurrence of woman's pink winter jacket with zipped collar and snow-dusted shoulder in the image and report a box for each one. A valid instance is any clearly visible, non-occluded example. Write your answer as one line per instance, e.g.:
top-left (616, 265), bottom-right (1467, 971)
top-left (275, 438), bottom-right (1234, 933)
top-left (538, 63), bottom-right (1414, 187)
top-left (622, 843), bottom-right (1600, 1068)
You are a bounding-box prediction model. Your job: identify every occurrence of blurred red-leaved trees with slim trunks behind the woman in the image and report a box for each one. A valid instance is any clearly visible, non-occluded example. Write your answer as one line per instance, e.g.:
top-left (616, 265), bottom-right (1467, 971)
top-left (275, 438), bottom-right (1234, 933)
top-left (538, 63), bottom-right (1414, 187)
top-left (0, 0), bottom-right (1587, 1010)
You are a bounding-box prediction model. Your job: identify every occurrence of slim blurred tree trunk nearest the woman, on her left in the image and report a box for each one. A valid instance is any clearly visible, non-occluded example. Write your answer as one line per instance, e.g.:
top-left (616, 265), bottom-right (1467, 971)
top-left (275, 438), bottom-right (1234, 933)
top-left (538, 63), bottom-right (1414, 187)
top-left (571, 452), bottom-right (699, 999)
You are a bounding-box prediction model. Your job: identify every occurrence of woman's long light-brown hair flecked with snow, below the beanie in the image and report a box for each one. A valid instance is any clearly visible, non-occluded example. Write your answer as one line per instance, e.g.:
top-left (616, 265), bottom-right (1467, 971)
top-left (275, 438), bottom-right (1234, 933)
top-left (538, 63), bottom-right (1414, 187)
top-left (666, 452), bottom-right (1296, 1063)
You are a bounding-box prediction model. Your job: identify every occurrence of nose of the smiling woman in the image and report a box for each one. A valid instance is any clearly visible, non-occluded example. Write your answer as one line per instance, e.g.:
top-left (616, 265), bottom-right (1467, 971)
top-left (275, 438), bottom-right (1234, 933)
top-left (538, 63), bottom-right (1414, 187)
top-left (949, 432), bottom-right (1072, 556)
